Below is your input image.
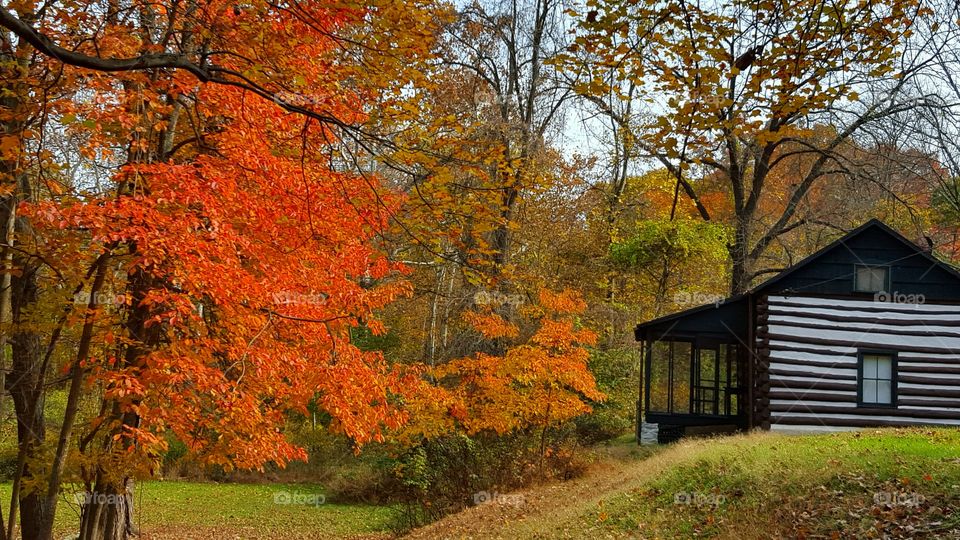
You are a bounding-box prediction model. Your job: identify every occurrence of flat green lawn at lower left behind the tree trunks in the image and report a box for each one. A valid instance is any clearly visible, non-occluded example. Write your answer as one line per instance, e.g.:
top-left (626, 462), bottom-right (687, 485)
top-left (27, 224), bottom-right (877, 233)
top-left (0, 482), bottom-right (395, 539)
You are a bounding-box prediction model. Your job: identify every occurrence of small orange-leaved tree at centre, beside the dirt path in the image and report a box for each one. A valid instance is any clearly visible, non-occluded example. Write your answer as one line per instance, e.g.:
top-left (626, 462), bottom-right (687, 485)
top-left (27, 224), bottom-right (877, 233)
top-left (403, 290), bottom-right (604, 437)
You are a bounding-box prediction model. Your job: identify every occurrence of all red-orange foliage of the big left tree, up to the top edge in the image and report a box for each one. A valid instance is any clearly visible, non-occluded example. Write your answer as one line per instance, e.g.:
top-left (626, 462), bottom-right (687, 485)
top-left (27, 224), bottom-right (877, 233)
top-left (22, 2), bottom-right (438, 468)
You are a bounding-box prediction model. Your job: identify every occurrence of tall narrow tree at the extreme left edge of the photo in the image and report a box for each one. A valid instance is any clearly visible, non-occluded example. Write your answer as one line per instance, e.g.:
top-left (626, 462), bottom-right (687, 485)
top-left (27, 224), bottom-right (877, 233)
top-left (0, 6), bottom-right (54, 538)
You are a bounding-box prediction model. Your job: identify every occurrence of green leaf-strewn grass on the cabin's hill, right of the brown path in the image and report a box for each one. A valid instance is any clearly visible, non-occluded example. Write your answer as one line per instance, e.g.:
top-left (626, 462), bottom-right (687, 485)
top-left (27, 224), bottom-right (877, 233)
top-left (564, 429), bottom-right (960, 538)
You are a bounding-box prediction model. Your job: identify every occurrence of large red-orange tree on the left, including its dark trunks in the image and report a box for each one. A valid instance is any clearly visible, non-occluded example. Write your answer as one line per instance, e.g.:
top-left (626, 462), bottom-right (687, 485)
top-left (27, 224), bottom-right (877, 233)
top-left (0, 1), bottom-right (442, 538)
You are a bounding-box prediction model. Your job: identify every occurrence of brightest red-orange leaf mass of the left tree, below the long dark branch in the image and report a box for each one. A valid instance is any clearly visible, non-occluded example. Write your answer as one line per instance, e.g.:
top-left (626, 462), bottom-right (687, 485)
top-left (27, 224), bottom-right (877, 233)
top-left (30, 86), bottom-right (416, 466)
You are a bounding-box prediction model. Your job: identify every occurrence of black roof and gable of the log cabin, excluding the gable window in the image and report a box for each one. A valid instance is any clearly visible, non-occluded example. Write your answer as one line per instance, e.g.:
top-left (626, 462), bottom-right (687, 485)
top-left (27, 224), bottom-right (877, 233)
top-left (635, 219), bottom-right (960, 340)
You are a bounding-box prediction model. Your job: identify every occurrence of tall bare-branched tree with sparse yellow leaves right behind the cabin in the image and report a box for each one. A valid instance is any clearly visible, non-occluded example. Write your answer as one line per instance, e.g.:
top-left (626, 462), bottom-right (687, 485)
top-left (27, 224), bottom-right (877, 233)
top-left (578, 0), bottom-right (957, 293)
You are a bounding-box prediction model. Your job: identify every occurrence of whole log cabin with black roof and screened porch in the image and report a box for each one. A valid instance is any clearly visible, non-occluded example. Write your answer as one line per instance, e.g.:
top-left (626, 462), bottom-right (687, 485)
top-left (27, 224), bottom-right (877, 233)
top-left (635, 220), bottom-right (960, 443)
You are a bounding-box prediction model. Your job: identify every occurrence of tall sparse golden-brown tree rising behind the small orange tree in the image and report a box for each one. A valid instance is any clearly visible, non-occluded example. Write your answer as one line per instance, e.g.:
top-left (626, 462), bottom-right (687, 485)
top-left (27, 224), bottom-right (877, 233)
top-left (384, 0), bottom-right (573, 368)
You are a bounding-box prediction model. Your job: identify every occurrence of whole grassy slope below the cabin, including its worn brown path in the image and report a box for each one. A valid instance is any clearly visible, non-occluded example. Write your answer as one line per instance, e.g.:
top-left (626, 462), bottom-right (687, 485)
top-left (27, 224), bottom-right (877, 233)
top-left (412, 429), bottom-right (960, 538)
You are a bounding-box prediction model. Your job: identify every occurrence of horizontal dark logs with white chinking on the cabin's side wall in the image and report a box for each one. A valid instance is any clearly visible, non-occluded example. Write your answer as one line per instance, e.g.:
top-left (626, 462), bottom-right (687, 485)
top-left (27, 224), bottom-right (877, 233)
top-left (757, 296), bottom-right (960, 431)
